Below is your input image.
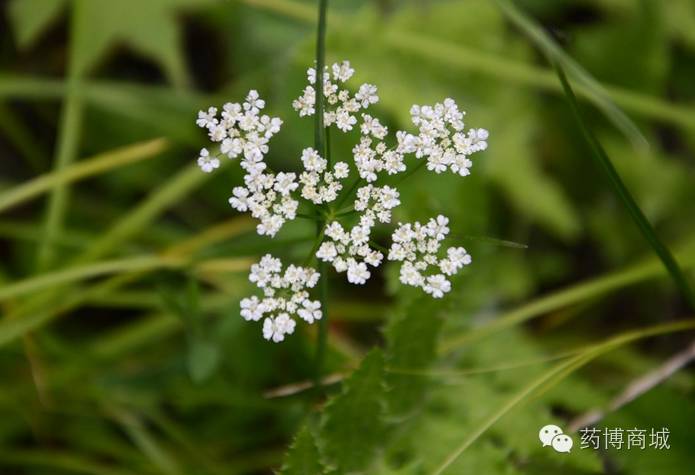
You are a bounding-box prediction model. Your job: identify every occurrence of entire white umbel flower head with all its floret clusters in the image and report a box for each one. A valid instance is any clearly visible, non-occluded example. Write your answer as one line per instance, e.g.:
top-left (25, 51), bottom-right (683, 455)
top-left (196, 61), bottom-right (488, 342)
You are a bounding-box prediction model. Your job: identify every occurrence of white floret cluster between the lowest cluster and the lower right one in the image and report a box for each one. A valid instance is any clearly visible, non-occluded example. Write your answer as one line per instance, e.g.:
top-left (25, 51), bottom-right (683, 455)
top-left (316, 221), bottom-right (384, 285)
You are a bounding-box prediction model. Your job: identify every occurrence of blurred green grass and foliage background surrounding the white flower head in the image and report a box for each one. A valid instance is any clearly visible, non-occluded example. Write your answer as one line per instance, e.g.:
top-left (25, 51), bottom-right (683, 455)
top-left (0, 0), bottom-right (695, 475)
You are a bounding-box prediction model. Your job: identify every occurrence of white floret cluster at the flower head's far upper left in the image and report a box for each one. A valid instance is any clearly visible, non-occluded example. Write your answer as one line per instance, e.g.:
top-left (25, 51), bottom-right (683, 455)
top-left (196, 90), bottom-right (282, 173)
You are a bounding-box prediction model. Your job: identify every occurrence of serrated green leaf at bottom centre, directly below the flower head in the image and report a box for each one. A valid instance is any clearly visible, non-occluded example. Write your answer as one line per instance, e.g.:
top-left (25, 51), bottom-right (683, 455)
top-left (321, 350), bottom-right (386, 473)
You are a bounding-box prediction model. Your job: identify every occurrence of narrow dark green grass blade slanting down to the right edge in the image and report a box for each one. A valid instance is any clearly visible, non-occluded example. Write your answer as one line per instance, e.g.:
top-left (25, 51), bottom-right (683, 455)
top-left (555, 64), bottom-right (695, 316)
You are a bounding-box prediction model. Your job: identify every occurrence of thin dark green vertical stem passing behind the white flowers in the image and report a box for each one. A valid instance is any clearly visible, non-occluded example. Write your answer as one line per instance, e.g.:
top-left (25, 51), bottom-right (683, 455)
top-left (309, 0), bottom-right (331, 390)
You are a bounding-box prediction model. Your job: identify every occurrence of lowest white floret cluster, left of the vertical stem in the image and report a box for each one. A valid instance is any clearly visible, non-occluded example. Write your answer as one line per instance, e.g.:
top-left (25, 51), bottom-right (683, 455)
top-left (241, 254), bottom-right (322, 343)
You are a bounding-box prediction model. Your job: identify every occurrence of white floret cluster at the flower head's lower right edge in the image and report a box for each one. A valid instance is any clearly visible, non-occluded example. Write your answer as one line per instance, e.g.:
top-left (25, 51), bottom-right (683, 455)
top-left (388, 215), bottom-right (471, 298)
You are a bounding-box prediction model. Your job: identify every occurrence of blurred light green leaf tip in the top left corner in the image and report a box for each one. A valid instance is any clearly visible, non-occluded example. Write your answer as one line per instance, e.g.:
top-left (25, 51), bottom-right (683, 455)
top-left (8, 0), bottom-right (65, 48)
